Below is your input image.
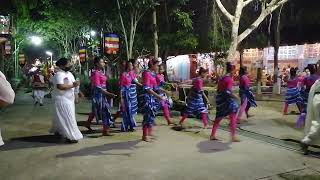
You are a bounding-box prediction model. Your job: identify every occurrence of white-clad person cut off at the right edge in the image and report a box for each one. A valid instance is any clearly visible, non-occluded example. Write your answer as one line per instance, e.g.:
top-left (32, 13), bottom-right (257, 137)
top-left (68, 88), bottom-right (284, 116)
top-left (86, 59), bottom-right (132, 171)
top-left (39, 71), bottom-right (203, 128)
top-left (301, 80), bottom-right (320, 154)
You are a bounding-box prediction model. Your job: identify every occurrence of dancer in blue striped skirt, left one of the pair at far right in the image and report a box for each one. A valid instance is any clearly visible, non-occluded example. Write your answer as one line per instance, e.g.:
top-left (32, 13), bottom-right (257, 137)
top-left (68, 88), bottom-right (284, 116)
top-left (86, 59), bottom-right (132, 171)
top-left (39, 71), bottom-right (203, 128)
top-left (283, 68), bottom-right (303, 115)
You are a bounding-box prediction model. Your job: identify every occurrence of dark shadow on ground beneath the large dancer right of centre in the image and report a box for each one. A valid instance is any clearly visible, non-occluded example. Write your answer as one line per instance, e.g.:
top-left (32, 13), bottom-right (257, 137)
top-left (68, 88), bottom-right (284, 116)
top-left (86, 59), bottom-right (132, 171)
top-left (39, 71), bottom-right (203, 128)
top-left (197, 141), bottom-right (231, 153)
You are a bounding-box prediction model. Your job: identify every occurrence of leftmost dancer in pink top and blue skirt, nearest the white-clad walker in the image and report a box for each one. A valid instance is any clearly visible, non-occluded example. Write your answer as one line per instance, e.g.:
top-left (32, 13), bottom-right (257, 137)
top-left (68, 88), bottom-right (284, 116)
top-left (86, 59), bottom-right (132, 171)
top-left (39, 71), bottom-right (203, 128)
top-left (86, 57), bottom-right (117, 136)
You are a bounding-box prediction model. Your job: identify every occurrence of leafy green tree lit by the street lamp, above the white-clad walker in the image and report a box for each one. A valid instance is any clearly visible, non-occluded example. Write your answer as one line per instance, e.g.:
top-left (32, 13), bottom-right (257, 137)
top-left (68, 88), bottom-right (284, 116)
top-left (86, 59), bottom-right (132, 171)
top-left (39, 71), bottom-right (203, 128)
top-left (35, 2), bottom-right (88, 57)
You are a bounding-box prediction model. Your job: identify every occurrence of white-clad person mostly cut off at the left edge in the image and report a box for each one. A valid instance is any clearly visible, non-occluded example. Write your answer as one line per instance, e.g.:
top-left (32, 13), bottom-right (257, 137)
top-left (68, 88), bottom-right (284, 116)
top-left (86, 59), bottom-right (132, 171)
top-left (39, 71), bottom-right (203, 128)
top-left (0, 71), bottom-right (15, 146)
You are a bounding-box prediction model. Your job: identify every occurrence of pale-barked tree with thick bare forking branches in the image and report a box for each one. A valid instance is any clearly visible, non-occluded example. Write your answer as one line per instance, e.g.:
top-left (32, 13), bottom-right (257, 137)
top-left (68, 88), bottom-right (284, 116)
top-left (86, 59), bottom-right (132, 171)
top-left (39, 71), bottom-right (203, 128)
top-left (216, 0), bottom-right (288, 61)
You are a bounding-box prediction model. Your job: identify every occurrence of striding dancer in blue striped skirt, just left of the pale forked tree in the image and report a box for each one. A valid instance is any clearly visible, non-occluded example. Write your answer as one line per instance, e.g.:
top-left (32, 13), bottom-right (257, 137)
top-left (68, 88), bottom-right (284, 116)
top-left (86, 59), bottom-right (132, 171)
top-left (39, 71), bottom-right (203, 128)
top-left (179, 67), bottom-right (209, 128)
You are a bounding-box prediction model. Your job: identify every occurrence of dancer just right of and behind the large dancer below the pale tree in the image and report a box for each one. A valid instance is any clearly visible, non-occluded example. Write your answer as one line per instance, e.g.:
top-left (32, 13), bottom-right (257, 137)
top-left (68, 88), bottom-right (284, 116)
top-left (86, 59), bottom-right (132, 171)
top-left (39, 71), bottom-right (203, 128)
top-left (238, 67), bottom-right (257, 123)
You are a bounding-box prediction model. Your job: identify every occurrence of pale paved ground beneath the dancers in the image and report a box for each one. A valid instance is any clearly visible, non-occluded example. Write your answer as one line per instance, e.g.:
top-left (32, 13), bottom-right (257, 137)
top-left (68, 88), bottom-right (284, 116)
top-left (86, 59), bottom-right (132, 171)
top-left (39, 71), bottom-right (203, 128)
top-left (0, 93), bottom-right (320, 180)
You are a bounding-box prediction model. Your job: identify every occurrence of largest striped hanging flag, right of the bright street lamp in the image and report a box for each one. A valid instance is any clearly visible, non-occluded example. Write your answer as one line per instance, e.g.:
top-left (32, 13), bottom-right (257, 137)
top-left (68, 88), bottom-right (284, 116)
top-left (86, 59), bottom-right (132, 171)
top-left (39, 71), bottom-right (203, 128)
top-left (104, 33), bottom-right (120, 55)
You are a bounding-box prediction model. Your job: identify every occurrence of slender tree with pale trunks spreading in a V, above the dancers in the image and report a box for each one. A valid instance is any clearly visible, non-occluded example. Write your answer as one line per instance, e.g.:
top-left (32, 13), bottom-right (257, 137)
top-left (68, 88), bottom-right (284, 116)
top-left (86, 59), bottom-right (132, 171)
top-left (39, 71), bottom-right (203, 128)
top-left (117, 0), bottom-right (154, 59)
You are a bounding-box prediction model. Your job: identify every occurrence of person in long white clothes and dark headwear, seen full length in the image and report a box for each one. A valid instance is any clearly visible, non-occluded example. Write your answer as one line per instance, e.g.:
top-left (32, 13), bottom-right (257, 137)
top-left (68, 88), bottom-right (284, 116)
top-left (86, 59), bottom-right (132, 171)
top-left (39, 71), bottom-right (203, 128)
top-left (50, 58), bottom-right (83, 143)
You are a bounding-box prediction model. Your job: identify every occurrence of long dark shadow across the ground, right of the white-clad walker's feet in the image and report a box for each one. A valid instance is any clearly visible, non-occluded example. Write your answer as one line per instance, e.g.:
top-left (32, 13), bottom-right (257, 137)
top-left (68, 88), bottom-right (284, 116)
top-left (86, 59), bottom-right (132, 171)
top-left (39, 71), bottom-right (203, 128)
top-left (56, 140), bottom-right (141, 158)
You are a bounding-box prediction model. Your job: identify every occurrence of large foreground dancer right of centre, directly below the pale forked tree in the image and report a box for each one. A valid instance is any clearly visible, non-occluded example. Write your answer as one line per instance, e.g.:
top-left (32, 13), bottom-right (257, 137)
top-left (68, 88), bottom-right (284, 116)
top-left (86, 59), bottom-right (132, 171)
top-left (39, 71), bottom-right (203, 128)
top-left (210, 62), bottom-right (240, 142)
